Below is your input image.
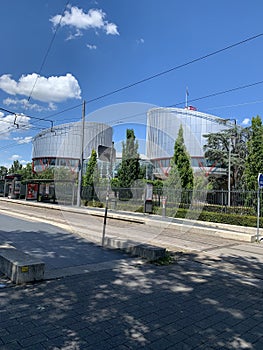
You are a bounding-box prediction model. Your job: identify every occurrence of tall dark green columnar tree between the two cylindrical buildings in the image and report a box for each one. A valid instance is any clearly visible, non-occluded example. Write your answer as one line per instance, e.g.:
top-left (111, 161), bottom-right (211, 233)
top-left (117, 129), bottom-right (140, 199)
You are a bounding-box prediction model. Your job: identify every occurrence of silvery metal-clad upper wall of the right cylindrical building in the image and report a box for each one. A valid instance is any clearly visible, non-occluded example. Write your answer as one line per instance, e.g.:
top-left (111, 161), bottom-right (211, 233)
top-left (146, 107), bottom-right (228, 175)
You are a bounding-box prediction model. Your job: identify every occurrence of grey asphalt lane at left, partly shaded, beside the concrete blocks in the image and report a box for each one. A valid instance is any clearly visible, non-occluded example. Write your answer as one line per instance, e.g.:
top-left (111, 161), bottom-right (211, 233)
top-left (0, 214), bottom-right (132, 277)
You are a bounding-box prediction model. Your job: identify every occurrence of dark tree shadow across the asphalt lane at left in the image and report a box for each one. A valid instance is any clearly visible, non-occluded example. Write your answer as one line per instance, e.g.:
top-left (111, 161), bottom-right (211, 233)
top-left (0, 225), bottom-right (129, 271)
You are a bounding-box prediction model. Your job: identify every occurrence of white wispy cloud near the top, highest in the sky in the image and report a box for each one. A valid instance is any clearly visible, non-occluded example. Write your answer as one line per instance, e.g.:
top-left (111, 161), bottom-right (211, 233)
top-left (50, 6), bottom-right (119, 35)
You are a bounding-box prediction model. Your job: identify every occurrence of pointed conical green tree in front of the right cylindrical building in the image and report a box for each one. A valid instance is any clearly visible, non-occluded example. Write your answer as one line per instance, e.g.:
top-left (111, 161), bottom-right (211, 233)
top-left (169, 125), bottom-right (194, 190)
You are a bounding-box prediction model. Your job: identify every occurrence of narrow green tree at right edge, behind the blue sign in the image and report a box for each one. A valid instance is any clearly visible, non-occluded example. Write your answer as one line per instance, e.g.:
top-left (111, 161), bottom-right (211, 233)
top-left (244, 116), bottom-right (263, 191)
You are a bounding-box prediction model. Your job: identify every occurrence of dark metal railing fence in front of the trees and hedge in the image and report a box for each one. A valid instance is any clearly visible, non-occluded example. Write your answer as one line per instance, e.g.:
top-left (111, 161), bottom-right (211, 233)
top-left (82, 186), bottom-right (262, 215)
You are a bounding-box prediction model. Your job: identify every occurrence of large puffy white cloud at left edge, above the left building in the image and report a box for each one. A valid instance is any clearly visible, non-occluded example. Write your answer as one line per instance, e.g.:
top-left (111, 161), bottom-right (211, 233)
top-left (0, 73), bottom-right (81, 102)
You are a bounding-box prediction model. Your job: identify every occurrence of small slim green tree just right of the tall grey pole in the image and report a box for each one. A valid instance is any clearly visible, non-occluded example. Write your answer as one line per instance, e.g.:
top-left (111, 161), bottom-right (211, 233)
top-left (83, 149), bottom-right (98, 201)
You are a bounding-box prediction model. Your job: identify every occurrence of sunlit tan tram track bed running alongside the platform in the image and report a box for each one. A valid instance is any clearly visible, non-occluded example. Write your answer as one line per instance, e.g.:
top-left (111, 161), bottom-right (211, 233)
top-left (0, 201), bottom-right (240, 252)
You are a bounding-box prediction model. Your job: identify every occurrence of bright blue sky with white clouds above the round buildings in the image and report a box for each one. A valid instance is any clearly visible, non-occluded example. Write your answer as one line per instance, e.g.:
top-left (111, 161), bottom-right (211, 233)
top-left (0, 0), bottom-right (263, 166)
